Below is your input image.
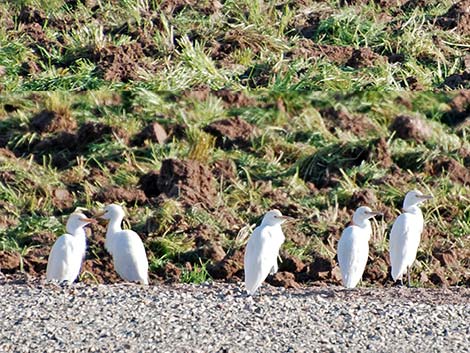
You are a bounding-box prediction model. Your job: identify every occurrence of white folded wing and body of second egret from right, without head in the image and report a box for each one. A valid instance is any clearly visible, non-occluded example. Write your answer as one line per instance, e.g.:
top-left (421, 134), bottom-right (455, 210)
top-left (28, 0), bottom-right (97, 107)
top-left (337, 226), bottom-right (370, 288)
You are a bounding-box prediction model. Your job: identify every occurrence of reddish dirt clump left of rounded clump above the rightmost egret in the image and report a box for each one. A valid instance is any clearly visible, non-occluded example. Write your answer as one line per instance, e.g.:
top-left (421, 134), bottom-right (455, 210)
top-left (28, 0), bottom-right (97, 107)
top-left (320, 108), bottom-right (376, 136)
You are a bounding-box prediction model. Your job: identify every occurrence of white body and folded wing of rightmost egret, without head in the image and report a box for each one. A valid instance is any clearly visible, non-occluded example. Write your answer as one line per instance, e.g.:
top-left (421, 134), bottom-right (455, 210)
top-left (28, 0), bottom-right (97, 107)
top-left (390, 213), bottom-right (422, 280)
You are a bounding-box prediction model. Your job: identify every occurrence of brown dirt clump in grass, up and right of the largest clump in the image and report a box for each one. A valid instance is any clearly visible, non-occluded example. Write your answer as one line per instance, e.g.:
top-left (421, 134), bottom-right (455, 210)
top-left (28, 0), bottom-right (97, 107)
top-left (204, 116), bottom-right (255, 148)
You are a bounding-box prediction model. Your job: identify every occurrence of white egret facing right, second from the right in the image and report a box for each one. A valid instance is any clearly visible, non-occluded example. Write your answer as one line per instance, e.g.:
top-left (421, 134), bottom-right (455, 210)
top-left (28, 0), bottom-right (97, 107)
top-left (338, 206), bottom-right (381, 288)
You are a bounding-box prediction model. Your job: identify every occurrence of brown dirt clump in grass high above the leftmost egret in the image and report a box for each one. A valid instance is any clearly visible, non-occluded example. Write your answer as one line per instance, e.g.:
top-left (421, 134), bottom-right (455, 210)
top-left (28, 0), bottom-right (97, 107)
top-left (31, 110), bottom-right (77, 133)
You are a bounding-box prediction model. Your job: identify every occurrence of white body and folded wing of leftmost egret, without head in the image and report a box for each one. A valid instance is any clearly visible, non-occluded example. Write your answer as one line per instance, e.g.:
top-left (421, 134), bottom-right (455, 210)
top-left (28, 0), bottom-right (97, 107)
top-left (46, 234), bottom-right (82, 282)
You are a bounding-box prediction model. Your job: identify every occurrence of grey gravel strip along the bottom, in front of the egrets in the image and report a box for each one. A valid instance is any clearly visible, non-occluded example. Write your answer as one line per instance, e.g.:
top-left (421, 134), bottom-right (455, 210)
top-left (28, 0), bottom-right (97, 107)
top-left (0, 280), bottom-right (470, 353)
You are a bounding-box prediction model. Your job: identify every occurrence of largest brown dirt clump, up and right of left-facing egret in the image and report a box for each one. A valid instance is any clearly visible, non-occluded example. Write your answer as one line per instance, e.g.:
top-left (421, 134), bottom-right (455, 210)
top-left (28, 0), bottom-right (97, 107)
top-left (140, 159), bottom-right (217, 208)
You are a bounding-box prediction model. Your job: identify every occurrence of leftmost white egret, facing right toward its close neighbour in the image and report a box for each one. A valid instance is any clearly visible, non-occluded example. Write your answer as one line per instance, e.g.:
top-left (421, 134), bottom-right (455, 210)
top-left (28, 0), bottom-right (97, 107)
top-left (46, 212), bottom-right (95, 283)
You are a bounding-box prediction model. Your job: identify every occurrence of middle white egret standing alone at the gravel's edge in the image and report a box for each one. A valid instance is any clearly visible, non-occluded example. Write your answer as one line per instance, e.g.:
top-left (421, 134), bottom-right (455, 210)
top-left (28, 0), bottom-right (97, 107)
top-left (244, 210), bottom-right (290, 295)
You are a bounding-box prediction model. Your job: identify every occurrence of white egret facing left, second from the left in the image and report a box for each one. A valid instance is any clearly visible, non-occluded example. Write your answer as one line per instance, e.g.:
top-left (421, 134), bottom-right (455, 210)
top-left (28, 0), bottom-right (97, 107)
top-left (102, 204), bottom-right (148, 284)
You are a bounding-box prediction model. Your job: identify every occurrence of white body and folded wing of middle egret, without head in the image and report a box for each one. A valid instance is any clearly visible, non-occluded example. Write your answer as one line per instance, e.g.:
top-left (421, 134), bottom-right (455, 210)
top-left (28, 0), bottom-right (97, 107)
top-left (244, 226), bottom-right (284, 294)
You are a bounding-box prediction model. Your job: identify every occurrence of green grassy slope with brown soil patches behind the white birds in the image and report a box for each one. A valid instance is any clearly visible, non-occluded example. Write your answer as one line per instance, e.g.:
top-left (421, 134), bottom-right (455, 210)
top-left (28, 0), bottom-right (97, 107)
top-left (0, 1), bottom-right (470, 285)
